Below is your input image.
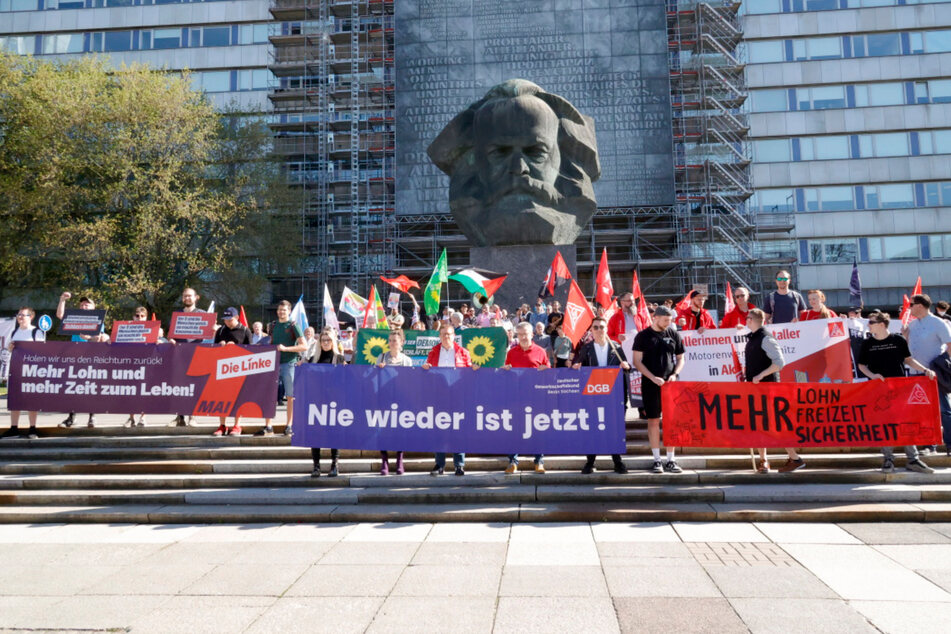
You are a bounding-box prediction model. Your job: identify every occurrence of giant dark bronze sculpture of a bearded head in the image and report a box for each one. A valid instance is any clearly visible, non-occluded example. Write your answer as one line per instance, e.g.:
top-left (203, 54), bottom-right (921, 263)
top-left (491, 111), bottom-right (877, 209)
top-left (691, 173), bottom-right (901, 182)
top-left (428, 79), bottom-right (601, 246)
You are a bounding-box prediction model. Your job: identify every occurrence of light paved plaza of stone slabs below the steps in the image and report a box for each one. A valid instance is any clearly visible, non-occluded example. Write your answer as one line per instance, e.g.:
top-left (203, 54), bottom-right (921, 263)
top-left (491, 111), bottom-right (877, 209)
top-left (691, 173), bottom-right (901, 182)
top-left (0, 523), bottom-right (951, 634)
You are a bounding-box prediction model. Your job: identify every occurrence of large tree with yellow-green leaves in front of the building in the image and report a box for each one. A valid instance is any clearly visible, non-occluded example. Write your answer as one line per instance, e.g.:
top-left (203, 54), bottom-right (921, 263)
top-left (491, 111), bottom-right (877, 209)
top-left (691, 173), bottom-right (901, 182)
top-left (0, 54), bottom-right (299, 314)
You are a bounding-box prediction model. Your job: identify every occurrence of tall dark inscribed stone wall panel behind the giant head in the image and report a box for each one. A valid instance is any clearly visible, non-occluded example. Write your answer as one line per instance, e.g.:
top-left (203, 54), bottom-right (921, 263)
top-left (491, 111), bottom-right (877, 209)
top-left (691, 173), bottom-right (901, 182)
top-left (395, 0), bottom-right (674, 214)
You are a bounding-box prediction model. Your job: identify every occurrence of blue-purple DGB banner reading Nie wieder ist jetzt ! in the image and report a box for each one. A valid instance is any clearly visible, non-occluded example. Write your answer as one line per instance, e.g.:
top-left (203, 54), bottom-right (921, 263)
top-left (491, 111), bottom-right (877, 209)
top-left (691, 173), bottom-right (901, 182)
top-left (292, 364), bottom-right (625, 454)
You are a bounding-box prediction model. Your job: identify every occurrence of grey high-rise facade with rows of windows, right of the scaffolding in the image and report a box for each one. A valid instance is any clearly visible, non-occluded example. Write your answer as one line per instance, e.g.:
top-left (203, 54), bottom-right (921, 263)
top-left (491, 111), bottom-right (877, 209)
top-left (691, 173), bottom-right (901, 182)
top-left (743, 0), bottom-right (951, 310)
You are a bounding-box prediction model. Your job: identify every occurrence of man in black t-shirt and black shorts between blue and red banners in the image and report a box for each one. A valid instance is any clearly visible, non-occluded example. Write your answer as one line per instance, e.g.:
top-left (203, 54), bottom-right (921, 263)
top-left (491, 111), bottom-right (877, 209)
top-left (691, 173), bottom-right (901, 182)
top-left (633, 306), bottom-right (684, 473)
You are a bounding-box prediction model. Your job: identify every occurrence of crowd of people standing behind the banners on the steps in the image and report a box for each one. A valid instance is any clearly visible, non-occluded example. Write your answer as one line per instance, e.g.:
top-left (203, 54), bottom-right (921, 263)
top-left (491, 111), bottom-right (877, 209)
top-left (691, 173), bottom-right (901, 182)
top-left (0, 270), bottom-right (951, 477)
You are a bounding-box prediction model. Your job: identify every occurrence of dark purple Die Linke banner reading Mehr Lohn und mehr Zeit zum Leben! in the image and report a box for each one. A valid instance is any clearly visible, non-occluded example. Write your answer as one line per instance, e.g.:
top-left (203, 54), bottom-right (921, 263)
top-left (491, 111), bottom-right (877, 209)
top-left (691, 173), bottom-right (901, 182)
top-left (7, 342), bottom-right (278, 418)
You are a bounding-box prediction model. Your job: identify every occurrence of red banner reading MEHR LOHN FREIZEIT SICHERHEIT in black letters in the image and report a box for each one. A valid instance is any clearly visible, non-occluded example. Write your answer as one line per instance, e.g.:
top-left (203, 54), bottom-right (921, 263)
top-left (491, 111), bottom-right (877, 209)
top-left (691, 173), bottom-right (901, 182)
top-left (661, 377), bottom-right (942, 447)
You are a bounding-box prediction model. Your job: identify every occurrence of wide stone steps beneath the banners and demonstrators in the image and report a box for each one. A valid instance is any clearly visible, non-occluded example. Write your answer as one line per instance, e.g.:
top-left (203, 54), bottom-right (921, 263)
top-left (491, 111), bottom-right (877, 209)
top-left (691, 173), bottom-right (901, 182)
top-left (0, 416), bottom-right (951, 523)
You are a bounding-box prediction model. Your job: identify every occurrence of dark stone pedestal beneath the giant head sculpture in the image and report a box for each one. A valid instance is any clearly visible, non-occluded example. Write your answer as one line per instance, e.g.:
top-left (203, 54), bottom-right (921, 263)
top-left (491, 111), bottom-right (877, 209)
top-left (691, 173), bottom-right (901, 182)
top-left (469, 244), bottom-right (578, 313)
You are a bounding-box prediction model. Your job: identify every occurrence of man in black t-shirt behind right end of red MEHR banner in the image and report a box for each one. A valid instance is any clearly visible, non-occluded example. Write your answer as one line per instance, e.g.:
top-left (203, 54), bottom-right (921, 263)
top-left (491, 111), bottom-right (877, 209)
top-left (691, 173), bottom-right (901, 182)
top-left (858, 311), bottom-right (934, 473)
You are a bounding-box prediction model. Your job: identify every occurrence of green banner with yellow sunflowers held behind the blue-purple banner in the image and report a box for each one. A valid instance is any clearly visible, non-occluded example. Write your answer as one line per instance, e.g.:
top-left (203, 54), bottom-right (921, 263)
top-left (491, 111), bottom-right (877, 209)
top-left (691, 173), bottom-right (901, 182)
top-left (353, 327), bottom-right (509, 368)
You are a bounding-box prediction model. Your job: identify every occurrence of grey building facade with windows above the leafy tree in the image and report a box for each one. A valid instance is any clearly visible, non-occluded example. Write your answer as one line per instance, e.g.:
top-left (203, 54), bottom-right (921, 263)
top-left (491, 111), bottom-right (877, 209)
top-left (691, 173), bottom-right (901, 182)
top-left (0, 0), bottom-right (271, 112)
